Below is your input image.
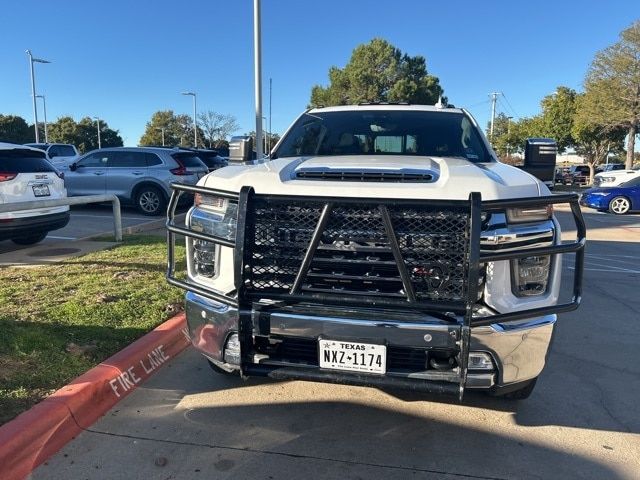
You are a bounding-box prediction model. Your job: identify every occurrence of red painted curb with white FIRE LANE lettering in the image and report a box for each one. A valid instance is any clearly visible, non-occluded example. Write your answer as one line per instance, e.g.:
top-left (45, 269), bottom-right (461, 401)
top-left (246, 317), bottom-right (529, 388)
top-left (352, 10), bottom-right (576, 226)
top-left (0, 314), bottom-right (189, 480)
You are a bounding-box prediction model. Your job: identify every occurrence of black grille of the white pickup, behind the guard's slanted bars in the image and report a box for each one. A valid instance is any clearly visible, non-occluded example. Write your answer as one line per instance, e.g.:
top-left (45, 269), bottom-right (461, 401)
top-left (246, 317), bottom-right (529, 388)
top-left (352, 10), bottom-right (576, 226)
top-left (243, 196), bottom-right (469, 302)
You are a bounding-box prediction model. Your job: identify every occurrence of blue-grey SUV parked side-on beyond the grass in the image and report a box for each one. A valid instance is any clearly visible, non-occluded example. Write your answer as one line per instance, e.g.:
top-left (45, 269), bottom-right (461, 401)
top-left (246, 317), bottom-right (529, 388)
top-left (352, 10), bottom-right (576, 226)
top-left (65, 147), bottom-right (209, 215)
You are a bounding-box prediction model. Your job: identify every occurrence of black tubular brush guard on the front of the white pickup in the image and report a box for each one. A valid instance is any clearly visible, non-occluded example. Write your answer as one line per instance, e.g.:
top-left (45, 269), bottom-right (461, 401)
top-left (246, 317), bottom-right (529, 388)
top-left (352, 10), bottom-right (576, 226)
top-left (166, 184), bottom-right (586, 398)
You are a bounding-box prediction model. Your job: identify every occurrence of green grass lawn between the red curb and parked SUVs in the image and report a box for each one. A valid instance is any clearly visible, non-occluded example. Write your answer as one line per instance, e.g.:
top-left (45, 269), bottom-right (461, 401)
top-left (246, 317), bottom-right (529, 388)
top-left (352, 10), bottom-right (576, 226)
top-left (0, 236), bottom-right (184, 424)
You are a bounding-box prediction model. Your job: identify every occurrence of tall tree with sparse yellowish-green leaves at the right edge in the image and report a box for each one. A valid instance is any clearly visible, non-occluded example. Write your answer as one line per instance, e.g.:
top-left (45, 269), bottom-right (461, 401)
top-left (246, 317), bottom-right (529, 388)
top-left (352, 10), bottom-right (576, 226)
top-left (585, 20), bottom-right (640, 169)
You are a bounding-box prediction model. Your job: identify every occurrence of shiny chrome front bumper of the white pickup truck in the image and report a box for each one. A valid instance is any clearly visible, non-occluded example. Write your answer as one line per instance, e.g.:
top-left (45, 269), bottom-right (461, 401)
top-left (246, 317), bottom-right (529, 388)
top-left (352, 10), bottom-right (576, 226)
top-left (186, 292), bottom-right (556, 389)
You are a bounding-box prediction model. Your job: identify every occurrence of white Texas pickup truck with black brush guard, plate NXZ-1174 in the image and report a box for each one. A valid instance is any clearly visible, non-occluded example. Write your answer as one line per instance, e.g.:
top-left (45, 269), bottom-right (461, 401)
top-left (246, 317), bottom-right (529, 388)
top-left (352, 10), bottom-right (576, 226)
top-left (167, 104), bottom-right (585, 398)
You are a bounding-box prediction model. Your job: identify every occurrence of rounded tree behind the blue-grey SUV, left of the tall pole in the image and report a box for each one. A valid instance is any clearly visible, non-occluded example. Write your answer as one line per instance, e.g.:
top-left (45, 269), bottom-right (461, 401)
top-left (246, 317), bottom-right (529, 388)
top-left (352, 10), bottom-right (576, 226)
top-left (140, 110), bottom-right (204, 147)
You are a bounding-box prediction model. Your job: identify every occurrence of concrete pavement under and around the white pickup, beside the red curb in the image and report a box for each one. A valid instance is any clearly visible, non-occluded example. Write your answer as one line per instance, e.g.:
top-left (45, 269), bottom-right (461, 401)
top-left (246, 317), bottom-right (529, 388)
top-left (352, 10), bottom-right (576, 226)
top-left (26, 209), bottom-right (640, 479)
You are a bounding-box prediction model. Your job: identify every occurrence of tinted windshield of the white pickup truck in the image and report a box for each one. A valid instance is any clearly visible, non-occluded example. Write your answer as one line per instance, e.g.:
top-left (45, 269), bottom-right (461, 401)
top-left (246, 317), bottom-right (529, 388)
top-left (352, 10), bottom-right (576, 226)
top-left (273, 110), bottom-right (491, 162)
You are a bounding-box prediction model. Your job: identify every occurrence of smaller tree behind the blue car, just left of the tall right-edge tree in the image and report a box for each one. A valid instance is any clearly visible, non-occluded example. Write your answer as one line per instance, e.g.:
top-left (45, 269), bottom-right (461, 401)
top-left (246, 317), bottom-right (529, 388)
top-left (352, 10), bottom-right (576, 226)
top-left (572, 92), bottom-right (625, 184)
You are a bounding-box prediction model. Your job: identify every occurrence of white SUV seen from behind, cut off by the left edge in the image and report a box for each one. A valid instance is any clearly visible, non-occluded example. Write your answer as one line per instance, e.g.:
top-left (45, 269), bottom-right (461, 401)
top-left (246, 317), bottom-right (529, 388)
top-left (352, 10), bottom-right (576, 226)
top-left (0, 143), bottom-right (69, 245)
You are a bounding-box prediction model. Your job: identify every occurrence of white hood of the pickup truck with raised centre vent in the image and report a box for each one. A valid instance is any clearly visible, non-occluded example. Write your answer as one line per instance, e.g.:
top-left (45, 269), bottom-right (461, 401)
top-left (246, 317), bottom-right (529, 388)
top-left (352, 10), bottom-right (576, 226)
top-left (199, 155), bottom-right (541, 200)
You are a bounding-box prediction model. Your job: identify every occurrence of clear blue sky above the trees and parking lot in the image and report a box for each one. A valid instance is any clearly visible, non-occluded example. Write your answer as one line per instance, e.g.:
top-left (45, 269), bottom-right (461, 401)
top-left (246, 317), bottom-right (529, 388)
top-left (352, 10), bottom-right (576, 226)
top-left (0, 0), bottom-right (638, 145)
